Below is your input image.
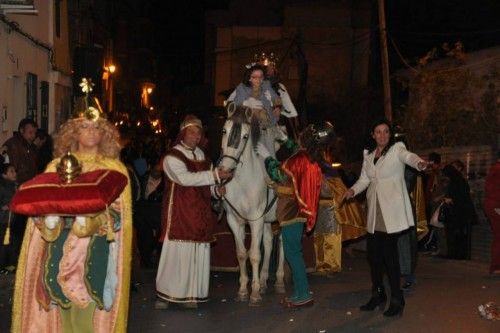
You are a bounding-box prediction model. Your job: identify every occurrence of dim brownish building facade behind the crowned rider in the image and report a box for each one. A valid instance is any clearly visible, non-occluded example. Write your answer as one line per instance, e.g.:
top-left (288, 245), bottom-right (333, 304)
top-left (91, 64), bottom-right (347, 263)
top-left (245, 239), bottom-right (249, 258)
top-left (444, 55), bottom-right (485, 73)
top-left (205, 0), bottom-right (373, 126)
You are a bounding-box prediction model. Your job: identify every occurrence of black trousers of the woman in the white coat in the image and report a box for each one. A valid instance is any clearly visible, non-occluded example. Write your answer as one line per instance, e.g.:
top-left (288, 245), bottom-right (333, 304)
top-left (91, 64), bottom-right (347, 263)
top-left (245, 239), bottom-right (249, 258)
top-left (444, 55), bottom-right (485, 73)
top-left (367, 231), bottom-right (403, 299)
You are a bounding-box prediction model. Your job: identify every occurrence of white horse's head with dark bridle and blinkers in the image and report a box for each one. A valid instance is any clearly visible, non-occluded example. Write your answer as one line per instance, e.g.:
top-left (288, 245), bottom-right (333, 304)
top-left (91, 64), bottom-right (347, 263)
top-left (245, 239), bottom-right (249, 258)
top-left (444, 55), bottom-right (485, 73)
top-left (219, 104), bottom-right (260, 170)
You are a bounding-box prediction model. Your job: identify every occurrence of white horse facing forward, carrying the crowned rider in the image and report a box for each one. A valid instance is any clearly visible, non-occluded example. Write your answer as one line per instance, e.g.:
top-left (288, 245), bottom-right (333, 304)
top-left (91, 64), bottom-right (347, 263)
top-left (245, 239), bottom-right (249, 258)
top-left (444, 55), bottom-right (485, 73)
top-left (219, 107), bottom-right (285, 305)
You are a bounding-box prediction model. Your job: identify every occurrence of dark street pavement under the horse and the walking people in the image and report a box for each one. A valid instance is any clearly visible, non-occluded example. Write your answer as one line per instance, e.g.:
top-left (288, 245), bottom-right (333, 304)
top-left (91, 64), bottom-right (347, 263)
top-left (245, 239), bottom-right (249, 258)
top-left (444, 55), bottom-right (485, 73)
top-left (0, 251), bottom-right (500, 333)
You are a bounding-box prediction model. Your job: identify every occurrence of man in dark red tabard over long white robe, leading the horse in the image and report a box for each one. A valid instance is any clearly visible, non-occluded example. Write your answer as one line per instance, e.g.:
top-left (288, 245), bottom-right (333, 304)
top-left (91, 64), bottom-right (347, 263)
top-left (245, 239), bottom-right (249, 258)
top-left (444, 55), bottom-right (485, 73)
top-left (155, 115), bottom-right (232, 309)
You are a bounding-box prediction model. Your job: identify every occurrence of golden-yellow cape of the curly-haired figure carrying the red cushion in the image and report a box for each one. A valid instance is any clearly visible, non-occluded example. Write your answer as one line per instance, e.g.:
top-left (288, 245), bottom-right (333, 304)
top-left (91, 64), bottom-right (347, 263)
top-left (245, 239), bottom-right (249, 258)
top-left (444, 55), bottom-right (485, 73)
top-left (11, 153), bottom-right (132, 333)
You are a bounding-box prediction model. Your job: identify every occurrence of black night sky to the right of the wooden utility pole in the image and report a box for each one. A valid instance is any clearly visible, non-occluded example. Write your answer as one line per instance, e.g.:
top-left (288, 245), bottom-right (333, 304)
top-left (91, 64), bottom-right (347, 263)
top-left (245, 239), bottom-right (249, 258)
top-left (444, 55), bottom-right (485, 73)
top-left (386, 0), bottom-right (500, 66)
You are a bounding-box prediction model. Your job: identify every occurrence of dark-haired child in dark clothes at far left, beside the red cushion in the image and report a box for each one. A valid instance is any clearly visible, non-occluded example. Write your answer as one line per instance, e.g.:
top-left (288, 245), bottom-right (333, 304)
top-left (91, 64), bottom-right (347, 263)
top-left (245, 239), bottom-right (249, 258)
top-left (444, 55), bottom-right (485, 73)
top-left (0, 163), bottom-right (17, 274)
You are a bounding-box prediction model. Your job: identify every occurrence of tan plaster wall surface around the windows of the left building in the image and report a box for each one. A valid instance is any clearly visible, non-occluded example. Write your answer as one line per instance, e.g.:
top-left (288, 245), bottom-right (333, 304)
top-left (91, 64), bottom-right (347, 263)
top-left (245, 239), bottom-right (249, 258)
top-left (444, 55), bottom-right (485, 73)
top-left (0, 0), bottom-right (71, 144)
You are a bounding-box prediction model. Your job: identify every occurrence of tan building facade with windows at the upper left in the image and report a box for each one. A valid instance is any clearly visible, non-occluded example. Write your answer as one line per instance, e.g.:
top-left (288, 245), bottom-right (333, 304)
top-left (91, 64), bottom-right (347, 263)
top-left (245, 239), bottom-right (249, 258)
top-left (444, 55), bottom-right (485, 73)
top-left (0, 0), bottom-right (72, 142)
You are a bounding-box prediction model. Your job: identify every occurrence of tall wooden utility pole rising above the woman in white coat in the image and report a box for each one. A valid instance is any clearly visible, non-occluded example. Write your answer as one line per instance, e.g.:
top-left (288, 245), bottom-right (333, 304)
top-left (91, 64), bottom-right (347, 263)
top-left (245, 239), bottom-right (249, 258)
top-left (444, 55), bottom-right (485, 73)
top-left (378, 0), bottom-right (392, 121)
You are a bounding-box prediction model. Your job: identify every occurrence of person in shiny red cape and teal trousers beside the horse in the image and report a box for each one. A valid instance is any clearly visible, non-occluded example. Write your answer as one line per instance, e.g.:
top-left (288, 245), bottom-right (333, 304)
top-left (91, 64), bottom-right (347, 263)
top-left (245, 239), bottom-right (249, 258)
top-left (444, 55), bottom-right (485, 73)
top-left (257, 122), bottom-right (335, 308)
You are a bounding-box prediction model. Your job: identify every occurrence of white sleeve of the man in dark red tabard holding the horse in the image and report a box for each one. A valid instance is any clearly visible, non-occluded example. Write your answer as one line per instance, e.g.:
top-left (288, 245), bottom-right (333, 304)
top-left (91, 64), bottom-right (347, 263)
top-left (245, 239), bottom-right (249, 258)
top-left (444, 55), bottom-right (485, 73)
top-left (163, 155), bottom-right (215, 186)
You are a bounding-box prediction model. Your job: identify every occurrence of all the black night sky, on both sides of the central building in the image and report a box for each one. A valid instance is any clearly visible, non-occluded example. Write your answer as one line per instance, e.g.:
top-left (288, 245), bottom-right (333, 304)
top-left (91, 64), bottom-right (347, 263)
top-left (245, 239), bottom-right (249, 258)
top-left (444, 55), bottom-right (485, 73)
top-left (143, 0), bottom-right (500, 85)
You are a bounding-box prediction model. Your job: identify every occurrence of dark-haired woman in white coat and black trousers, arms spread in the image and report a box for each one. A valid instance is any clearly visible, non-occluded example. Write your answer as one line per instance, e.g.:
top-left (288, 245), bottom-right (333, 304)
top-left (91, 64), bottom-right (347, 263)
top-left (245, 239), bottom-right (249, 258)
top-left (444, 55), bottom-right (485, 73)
top-left (343, 120), bottom-right (427, 317)
